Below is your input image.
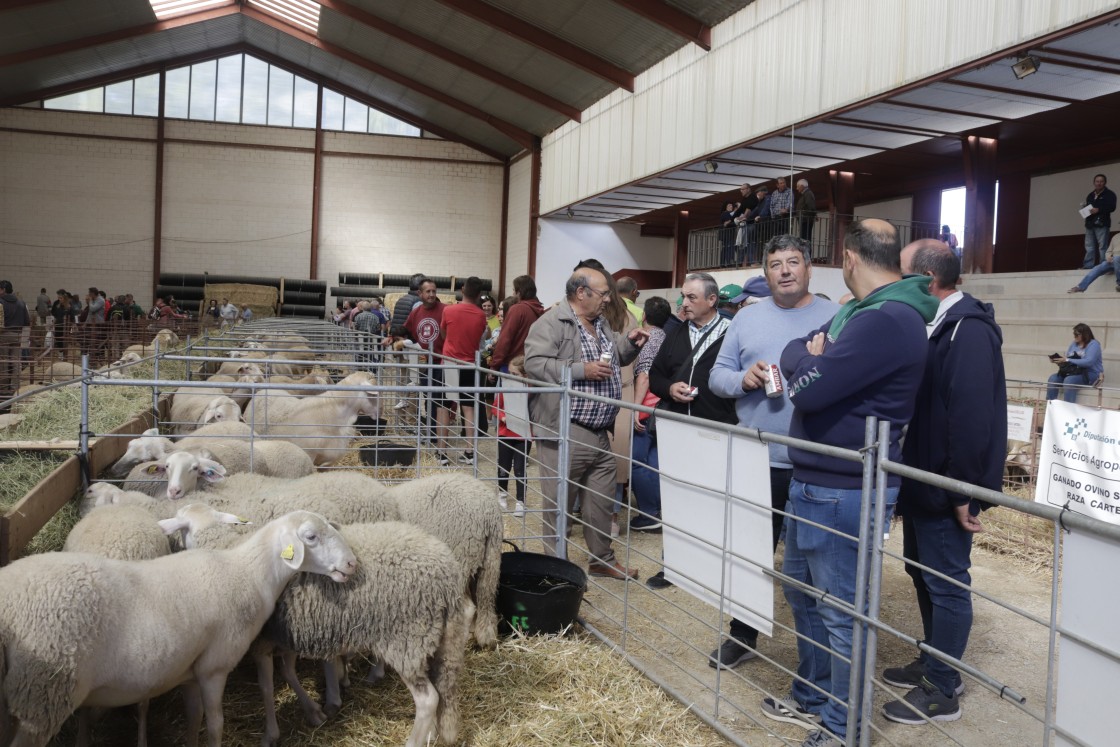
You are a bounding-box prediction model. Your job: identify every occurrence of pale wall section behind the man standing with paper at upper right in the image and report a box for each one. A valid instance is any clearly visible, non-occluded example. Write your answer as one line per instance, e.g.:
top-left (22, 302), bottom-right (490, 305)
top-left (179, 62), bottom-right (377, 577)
top-left (1027, 161), bottom-right (1120, 239)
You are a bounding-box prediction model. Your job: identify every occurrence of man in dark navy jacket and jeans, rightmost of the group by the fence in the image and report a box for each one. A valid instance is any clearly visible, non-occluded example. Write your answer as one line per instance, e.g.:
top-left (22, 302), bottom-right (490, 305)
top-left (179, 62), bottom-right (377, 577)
top-left (883, 239), bottom-right (1007, 725)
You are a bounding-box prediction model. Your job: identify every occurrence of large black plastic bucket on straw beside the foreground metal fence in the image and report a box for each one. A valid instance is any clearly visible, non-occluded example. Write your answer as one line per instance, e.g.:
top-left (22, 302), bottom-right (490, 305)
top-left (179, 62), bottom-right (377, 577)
top-left (497, 543), bottom-right (587, 635)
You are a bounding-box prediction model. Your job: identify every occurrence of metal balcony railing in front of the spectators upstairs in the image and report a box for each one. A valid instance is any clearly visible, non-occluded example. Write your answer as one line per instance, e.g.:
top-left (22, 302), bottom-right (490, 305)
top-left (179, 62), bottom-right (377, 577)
top-left (688, 213), bottom-right (941, 271)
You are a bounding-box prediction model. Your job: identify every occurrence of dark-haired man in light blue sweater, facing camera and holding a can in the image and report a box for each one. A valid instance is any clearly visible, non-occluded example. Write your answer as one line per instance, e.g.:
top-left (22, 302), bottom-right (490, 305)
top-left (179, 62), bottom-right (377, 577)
top-left (709, 234), bottom-right (840, 689)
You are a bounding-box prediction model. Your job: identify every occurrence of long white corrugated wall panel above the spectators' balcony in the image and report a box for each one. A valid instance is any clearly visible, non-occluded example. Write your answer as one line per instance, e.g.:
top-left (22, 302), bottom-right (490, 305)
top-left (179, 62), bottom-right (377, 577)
top-left (541, 0), bottom-right (1120, 213)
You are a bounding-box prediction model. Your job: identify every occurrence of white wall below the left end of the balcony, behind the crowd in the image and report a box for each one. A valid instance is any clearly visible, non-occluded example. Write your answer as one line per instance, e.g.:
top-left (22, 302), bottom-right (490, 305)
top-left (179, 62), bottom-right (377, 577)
top-left (534, 218), bottom-right (673, 306)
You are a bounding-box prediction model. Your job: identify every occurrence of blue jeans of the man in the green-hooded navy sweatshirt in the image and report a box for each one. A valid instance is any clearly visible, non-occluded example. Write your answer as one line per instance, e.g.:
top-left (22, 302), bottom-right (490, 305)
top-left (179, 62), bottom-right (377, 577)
top-left (782, 479), bottom-right (898, 739)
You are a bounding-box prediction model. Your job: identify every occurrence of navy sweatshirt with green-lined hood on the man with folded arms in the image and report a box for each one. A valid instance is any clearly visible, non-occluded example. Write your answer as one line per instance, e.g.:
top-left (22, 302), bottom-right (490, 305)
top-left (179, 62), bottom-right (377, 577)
top-left (782, 276), bottom-right (937, 489)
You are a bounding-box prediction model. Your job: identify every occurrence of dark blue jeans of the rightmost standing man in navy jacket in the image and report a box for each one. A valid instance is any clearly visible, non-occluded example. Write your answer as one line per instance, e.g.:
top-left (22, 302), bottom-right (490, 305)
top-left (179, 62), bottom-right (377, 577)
top-left (903, 516), bottom-right (972, 697)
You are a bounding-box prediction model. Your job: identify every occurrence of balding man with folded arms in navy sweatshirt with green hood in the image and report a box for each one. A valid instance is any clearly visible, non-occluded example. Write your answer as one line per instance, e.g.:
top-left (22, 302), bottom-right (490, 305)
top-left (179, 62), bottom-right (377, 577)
top-left (779, 220), bottom-right (937, 747)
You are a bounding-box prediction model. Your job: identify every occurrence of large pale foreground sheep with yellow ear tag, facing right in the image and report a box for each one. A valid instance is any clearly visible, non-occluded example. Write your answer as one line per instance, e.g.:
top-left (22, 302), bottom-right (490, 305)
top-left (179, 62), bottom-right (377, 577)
top-left (0, 512), bottom-right (357, 746)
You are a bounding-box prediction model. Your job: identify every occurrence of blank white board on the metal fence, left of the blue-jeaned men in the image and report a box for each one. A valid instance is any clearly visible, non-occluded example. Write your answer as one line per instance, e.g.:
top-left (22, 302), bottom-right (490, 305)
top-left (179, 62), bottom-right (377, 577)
top-left (657, 419), bottom-right (774, 635)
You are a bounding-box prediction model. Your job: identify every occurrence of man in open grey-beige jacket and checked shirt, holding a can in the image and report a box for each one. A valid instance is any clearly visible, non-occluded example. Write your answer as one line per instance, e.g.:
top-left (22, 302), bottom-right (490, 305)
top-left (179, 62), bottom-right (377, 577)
top-left (525, 268), bottom-right (650, 579)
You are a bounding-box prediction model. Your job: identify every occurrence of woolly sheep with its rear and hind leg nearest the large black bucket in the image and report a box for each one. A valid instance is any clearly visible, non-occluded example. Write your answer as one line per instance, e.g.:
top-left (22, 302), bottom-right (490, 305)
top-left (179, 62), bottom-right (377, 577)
top-left (388, 474), bottom-right (503, 648)
